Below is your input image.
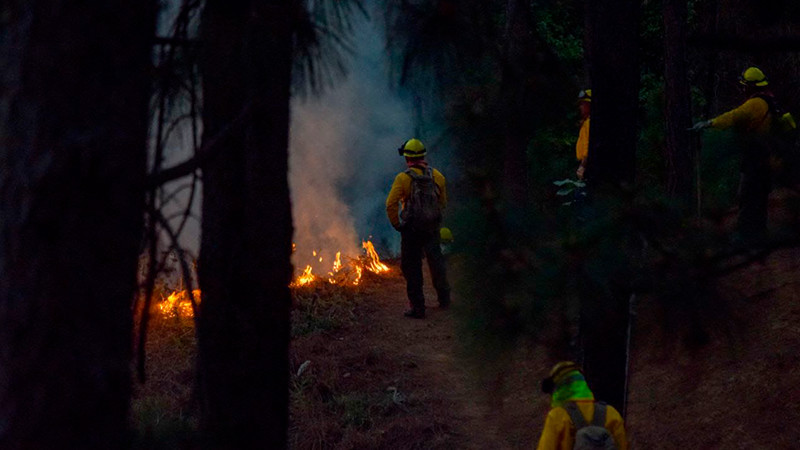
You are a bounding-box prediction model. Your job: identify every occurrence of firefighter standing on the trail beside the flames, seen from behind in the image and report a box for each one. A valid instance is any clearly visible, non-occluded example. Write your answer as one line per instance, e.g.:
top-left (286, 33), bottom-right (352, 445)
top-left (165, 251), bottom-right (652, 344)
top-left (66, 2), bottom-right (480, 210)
top-left (386, 138), bottom-right (450, 319)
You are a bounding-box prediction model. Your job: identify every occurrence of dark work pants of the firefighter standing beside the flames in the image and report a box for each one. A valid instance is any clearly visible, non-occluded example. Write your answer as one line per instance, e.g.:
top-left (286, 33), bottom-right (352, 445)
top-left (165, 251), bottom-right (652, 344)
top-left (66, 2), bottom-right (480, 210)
top-left (400, 231), bottom-right (450, 311)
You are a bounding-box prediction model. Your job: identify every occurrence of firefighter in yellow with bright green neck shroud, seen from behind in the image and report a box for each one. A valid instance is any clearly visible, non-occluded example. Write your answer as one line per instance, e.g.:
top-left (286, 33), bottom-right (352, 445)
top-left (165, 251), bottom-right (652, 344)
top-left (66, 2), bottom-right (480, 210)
top-left (536, 361), bottom-right (628, 450)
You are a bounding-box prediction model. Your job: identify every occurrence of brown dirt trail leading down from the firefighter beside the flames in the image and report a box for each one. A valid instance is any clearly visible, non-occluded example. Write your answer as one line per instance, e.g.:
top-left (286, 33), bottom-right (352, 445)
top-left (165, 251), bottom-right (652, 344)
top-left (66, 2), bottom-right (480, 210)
top-left (340, 267), bottom-right (546, 449)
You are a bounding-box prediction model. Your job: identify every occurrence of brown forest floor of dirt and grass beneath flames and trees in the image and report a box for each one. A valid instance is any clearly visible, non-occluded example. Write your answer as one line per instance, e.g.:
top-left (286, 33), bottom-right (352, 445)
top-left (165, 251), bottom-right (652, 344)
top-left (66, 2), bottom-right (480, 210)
top-left (133, 199), bottom-right (800, 449)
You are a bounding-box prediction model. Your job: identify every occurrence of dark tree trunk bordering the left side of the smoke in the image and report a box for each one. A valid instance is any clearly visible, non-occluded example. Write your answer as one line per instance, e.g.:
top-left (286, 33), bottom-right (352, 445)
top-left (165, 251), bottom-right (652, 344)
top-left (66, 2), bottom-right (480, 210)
top-left (198, 0), bottom-right (293, 448)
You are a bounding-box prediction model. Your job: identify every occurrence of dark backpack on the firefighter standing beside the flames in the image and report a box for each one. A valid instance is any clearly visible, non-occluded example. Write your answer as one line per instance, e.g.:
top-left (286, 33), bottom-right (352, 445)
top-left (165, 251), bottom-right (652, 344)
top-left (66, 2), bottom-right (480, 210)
top-left (400, 167), bottom-right (442, 233)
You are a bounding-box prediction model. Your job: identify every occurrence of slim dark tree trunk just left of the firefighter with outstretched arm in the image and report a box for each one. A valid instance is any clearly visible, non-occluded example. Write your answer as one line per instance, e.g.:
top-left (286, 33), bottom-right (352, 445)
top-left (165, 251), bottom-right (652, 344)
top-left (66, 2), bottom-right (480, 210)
top-left (664, 0), bottom-right (694, 207)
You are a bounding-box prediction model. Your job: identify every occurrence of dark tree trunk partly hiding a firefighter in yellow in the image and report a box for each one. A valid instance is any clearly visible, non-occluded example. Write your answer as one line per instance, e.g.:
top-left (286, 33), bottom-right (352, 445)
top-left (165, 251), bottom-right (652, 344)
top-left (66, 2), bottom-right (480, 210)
top-left (581, 0), bottom-right (639, 411)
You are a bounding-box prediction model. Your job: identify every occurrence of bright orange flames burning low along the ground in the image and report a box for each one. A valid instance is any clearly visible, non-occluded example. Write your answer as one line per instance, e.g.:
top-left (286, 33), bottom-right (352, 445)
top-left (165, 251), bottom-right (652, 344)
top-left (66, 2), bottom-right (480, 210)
top-left (156, 241), bottom-right (390, 317)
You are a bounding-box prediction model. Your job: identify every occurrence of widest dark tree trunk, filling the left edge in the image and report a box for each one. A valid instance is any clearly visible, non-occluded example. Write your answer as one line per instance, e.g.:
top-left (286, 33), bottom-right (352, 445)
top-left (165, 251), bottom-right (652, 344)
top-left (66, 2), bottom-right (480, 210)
top-left (0, 0), bottom-right (156, 449)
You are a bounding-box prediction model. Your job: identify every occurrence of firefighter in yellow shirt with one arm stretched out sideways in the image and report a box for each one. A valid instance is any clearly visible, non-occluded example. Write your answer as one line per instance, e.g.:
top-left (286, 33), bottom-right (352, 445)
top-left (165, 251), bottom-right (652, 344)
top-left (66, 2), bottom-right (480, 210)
top-left (691, 67), bottom-right (775, 241)
